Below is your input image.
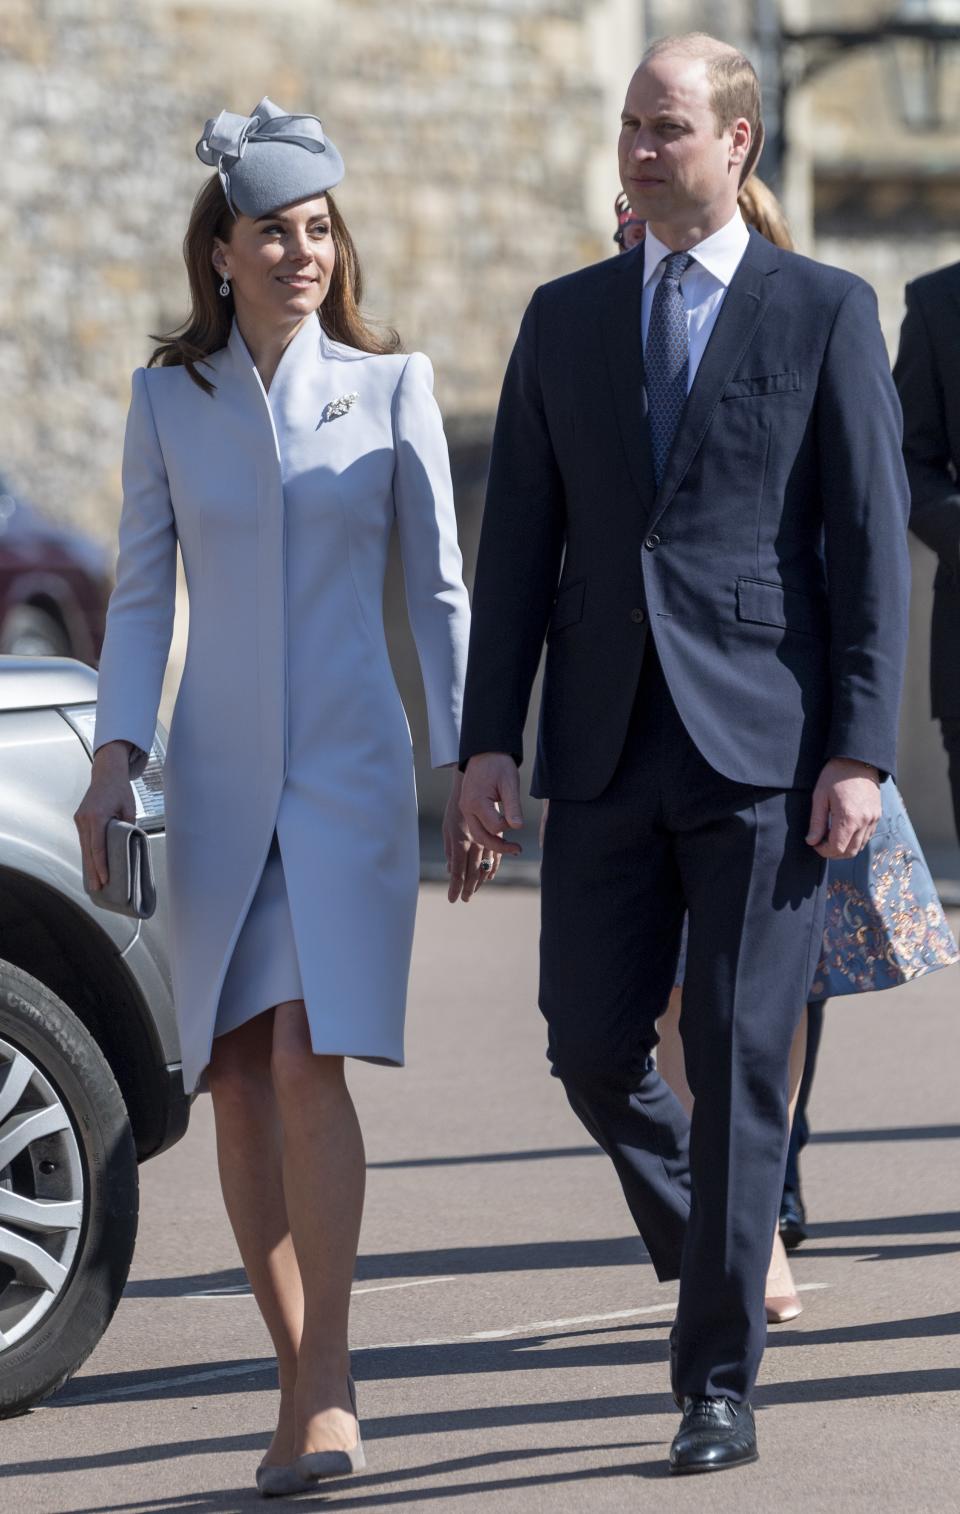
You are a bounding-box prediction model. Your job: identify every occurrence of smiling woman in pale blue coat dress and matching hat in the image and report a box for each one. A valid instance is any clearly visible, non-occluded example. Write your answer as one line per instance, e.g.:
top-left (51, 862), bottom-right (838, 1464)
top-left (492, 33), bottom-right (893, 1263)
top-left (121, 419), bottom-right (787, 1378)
top-left (77, 100), bottom-right (484, 1494)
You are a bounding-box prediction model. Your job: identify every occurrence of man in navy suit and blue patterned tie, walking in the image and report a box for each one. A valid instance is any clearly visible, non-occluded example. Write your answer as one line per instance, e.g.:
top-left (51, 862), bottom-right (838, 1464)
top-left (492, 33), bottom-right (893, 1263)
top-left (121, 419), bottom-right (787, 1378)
top-left (460, 36), bottom-right (909, 1472)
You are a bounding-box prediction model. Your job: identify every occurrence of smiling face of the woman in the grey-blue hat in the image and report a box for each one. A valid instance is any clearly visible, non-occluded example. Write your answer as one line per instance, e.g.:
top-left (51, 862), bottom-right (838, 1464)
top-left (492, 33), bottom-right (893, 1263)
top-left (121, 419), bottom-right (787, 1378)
top-left (214, 195), bottom-right (336, 324)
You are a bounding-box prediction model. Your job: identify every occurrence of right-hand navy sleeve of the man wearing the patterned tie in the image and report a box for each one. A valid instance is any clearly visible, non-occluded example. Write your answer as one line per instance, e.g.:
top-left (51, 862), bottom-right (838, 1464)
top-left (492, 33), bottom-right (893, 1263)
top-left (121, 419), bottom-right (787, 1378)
top-left (818, 280), bottom-right (910, 774)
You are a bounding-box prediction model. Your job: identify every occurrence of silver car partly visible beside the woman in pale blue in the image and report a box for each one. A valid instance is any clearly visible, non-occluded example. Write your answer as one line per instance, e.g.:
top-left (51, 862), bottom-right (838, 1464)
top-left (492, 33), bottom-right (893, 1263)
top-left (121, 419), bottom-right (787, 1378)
top-left (0, 657), bottom-right (189, 1417)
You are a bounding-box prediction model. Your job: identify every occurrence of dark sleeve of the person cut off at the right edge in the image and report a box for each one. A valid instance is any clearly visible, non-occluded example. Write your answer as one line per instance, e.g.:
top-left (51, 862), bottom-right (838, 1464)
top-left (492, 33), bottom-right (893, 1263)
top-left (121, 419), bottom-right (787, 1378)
top-left (893, 285), bottom-right (960, 569)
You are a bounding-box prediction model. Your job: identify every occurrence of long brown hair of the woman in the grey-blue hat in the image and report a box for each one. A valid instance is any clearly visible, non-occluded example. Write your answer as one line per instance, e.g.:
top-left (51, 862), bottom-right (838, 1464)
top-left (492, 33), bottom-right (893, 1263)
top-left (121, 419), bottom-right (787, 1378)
top-left (147, 174), bottom-right (400, 394)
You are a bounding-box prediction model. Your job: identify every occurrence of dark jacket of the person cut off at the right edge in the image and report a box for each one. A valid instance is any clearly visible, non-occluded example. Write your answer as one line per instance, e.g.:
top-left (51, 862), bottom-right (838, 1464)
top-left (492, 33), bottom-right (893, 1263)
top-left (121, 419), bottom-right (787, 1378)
top-left (893, 263), bottom-right (960, 719)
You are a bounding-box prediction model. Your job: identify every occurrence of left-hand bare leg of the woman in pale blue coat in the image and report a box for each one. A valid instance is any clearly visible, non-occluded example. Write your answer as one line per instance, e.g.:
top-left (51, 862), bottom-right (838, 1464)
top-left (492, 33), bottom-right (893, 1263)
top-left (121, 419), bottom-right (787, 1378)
top-left (207, 1010), bottom-right (303, 1466)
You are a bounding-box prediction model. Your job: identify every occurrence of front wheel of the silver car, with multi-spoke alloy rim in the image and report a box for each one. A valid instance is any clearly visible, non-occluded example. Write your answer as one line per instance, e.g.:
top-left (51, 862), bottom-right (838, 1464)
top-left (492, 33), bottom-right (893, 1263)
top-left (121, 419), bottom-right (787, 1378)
top-left (0, 961), bottom-right (139, 1419)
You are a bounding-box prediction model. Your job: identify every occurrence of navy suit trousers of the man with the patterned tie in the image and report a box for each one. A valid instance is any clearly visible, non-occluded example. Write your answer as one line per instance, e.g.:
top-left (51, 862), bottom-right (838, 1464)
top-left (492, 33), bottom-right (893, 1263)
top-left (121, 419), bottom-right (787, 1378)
top-left (541, 642), bottom-right (825, 1400)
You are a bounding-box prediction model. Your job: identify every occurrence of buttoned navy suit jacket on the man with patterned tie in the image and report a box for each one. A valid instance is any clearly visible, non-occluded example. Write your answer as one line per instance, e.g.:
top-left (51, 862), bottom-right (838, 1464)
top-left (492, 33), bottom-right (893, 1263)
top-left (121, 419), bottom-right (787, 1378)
top-left (460, 233), bottom-right (910, 799)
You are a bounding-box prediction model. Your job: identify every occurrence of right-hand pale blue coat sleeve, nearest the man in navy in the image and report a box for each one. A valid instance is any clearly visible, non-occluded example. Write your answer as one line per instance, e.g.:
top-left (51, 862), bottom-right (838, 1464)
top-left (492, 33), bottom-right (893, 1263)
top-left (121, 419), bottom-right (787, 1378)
top-left (394, 353), bottom-right (469, 768)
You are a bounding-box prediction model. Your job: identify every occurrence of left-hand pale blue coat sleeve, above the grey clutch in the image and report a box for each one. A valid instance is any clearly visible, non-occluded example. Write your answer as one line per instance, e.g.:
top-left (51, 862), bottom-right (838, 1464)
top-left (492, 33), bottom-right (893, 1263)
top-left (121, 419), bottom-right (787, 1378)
top-left (94, 368), bottom-right (177, 778)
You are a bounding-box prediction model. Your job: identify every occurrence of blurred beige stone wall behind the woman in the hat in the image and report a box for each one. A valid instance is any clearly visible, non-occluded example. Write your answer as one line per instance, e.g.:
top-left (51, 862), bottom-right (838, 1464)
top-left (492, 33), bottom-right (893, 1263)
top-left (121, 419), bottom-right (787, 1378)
top-left (0, 0), bottom-right (621, 536)
